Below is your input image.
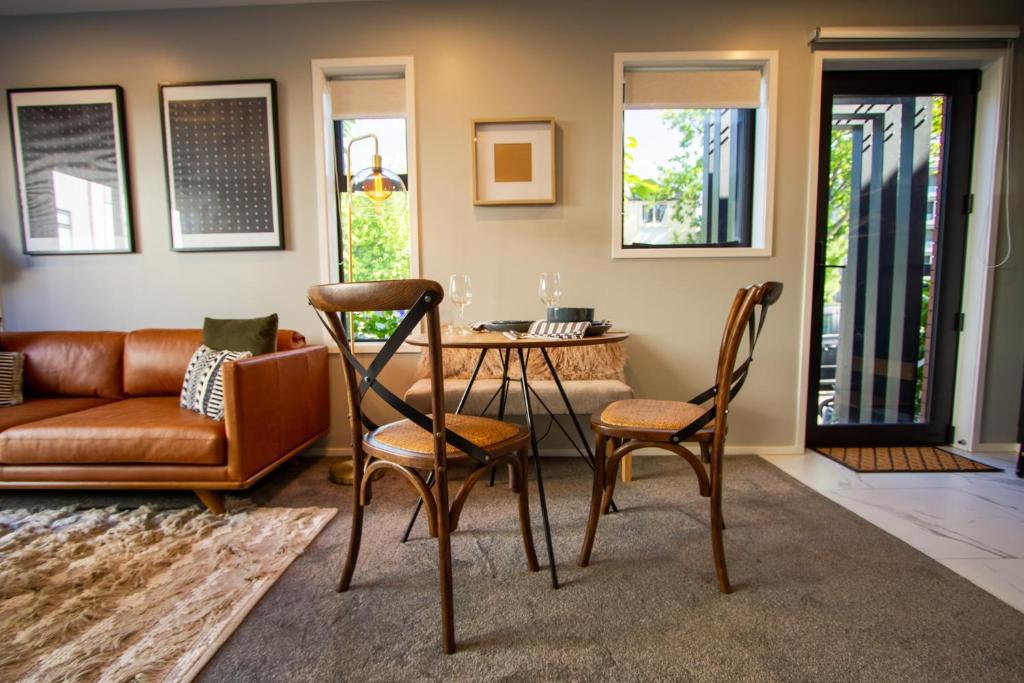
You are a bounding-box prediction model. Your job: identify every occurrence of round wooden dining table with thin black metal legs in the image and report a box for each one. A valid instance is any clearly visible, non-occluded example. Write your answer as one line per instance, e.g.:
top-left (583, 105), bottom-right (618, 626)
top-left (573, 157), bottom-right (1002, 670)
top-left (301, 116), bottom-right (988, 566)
top-left (402, 331), bottom-right (630, 588)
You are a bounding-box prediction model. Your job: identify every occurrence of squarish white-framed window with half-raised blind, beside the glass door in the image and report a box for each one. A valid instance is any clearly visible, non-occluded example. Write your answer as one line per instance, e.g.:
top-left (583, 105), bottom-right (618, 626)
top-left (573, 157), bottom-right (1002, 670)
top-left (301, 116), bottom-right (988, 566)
top-left (612, 52), bottom-right (776, 258)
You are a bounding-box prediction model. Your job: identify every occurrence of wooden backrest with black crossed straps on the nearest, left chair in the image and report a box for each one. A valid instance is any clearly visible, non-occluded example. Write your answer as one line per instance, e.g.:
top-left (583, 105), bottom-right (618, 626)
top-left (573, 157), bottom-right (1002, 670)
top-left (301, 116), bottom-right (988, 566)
top-left (308, 280), bottom-right (487, 465)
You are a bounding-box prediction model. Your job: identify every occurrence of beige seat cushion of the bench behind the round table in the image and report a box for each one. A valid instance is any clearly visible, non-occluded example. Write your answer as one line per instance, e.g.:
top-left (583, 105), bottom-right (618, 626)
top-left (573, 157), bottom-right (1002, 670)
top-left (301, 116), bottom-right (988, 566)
top-left (406, 379), bottom-right (633, 415)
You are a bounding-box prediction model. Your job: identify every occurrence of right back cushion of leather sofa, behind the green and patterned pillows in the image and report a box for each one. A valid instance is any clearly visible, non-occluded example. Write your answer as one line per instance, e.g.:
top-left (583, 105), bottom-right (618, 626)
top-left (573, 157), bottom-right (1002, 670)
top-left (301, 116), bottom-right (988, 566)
top-left (125, 330), bottom-right (306, 396)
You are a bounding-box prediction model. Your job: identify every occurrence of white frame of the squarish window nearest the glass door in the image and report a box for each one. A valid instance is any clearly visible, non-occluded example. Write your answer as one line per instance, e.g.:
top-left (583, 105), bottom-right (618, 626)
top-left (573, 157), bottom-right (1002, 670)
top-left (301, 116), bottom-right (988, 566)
top-left (611, 50), bottom-right (778, 259)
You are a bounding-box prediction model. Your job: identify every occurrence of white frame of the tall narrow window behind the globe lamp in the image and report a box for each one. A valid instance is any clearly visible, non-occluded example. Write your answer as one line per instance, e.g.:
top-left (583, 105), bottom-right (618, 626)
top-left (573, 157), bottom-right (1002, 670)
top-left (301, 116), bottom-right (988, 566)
top-left (311, 56), bottom-right (421, 353)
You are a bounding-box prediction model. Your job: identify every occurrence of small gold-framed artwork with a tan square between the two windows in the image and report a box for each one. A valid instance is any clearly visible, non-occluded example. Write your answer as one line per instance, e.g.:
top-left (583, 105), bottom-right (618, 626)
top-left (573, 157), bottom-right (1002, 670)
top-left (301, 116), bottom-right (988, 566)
top-left (472, 117), bottom-right (555, 206)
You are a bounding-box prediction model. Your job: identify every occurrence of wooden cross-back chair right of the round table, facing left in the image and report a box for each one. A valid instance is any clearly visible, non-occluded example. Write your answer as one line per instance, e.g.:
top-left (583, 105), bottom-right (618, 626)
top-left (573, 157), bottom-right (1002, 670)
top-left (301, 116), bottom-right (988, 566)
top-left (579, 282), bottom-right (782, 593)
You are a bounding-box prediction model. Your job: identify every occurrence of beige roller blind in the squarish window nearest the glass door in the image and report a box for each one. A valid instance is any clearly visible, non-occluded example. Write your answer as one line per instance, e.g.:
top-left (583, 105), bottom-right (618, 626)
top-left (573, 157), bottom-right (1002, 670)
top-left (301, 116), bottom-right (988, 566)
top-left (624, 69), bottom-right (761, 109)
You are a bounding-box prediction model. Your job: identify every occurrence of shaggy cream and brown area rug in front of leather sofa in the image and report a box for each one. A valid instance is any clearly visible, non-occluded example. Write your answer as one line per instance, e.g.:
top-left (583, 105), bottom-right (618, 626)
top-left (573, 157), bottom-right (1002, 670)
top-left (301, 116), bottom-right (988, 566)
top-left (0, 499), bottom-right (337, 681)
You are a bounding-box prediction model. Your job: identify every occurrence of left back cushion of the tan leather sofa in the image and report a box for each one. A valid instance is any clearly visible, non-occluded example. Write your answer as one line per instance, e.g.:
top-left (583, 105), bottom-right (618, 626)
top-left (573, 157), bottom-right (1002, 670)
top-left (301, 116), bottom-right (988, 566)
top-left (0, 332), bottom-right (125, 398)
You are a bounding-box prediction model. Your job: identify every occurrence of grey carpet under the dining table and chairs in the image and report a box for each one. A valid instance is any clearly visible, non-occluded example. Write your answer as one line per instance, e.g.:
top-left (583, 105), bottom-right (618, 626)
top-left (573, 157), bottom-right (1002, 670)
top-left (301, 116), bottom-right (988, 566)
top-left (0, 457), bottom-right (1024, 681)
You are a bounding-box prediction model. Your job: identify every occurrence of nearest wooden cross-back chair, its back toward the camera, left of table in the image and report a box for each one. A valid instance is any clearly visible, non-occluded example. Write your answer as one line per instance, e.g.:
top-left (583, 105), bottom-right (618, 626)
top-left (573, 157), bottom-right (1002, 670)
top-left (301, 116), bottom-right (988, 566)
top-left (308, 280), bottom-right (538, 653)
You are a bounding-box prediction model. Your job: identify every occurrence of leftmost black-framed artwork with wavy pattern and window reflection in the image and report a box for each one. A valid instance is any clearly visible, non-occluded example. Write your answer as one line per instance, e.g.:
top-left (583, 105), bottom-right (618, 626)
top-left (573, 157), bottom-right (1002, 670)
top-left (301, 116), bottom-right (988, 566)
top-left (7, 85), bottom-right (134, 255)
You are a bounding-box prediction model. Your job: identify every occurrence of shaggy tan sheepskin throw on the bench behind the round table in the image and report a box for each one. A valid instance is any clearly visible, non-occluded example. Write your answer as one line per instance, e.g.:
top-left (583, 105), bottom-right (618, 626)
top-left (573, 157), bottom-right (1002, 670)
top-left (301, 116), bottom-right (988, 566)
top-left (416, 343), bottom-right (627, 382)
